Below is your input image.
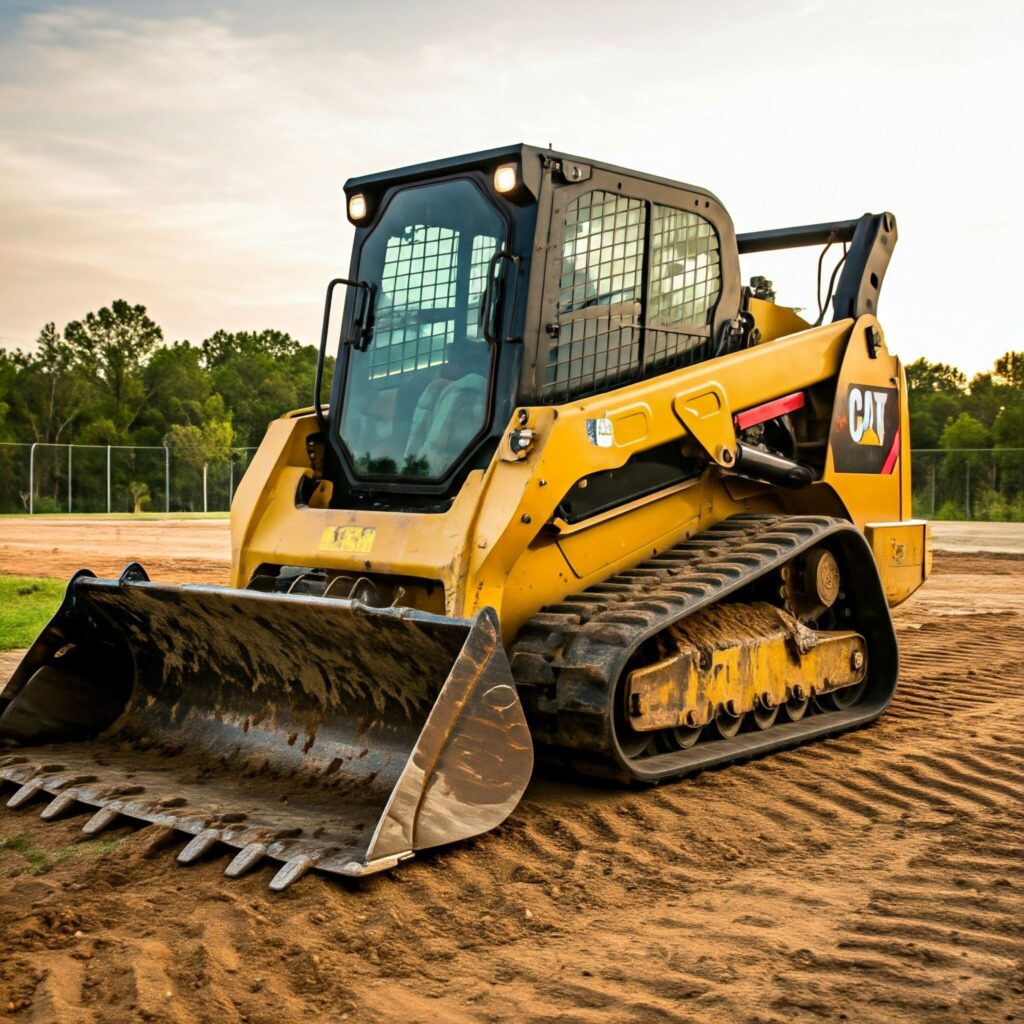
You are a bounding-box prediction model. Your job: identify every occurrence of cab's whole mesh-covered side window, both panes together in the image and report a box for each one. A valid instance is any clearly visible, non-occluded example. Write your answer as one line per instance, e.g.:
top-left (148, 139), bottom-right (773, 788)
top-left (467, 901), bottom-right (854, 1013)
top-left (544, 191), bottom-right (721, 401)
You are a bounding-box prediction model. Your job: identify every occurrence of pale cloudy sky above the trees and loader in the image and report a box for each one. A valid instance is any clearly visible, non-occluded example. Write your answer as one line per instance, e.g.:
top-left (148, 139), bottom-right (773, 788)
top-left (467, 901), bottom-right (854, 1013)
top-left (0, 0), bottom-right (1024, 374)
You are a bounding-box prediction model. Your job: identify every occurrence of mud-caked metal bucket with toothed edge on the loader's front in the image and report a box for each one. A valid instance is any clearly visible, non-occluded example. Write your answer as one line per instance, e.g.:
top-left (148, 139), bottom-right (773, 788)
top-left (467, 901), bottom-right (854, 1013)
top-left (0, 566), bottom-right (532, 889)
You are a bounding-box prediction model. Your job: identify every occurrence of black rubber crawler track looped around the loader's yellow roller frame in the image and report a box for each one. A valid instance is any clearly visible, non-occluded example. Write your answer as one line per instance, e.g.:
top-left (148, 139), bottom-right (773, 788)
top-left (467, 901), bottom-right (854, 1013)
top-left (511, 514), bottom-right (899, 782)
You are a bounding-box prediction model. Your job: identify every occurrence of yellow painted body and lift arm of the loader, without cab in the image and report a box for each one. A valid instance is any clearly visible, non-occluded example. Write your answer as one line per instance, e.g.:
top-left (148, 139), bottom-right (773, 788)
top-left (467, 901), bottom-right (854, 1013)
top-left (231, 311), bottom-right (930, 644)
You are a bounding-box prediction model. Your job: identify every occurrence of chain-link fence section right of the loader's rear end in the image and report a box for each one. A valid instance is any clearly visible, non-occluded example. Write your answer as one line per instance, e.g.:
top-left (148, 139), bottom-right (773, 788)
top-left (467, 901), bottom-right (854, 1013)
top-left (910, 447), bottom-right (1024, 522)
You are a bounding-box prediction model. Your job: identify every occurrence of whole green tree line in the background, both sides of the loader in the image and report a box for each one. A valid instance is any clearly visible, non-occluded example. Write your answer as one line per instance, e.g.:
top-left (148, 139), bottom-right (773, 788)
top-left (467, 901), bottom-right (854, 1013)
top-left (0, 299), bottom-right (1024, 519)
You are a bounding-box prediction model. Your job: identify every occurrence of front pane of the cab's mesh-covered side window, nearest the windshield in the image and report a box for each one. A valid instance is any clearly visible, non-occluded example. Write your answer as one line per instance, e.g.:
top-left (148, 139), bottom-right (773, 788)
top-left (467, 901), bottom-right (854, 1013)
top-left (544, 191), bottom-right (646, 398)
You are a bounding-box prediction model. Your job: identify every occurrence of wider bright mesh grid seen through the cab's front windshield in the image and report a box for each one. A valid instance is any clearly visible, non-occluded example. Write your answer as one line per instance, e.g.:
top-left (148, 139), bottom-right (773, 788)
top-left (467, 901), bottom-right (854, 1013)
top-left (370, 224), bottom-right (459, 378)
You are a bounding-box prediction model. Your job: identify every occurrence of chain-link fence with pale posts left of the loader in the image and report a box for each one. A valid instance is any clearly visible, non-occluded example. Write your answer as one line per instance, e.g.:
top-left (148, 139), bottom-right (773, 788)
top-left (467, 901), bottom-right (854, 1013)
top-left (0, 442), bottom-right (256, 514)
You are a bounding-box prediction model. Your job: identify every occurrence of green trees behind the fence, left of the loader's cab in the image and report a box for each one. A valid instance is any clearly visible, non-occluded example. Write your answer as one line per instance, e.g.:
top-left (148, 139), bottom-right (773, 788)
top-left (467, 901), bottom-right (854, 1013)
top-left (0, 299), bottom-right (331, 512)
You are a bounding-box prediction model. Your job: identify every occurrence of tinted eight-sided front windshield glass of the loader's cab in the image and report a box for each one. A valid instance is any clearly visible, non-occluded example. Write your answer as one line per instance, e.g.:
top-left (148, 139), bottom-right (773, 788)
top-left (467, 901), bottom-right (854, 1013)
top-left (339, 179), bottom-right (505, 479)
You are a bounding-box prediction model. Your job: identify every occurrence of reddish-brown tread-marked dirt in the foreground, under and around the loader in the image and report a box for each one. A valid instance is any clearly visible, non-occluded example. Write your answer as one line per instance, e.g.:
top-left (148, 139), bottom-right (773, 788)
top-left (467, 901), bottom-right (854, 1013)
top-left (0, 523), bottom-right (1024, 1024)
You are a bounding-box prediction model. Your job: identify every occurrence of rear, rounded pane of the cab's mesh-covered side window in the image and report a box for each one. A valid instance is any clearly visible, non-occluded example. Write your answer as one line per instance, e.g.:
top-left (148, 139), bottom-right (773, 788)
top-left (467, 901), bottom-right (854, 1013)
top-left (645, 205), bottom-right (722, 369)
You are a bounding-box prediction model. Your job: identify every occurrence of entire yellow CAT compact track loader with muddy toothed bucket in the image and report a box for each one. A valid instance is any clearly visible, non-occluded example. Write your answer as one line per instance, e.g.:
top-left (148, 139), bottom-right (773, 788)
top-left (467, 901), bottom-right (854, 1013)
top-left (0, 145), bottom-right (930, 889)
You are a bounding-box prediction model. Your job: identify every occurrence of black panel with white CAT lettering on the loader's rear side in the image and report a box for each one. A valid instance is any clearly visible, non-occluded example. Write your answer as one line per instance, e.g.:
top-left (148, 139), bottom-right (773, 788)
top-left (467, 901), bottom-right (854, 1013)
top-left (831, 384), bottom-right (900, 474)
